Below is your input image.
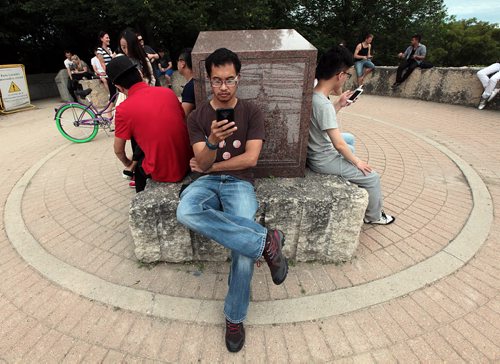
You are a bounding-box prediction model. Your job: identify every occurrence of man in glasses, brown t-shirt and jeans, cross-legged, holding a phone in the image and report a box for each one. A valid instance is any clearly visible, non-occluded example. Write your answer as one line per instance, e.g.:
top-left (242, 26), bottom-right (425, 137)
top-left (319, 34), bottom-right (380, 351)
top-left (177, 48), bottom-right (288, 352)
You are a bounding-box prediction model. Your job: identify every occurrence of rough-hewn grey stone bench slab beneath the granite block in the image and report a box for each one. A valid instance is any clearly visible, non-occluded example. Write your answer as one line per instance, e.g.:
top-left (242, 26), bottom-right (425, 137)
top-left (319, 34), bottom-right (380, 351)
top-left (129, 171), bottom-right (368, 263)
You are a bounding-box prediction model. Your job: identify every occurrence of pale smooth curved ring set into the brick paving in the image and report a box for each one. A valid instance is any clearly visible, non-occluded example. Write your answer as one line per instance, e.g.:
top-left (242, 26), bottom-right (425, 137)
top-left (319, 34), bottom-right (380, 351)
top-left (4, 114), bottom-right (493, 325)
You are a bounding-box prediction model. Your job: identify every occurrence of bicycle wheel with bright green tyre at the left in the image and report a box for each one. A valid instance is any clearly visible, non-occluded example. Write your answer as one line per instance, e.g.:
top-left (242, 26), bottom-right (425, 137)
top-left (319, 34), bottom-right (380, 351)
top-left (55, 103), bottom-right (99, 143)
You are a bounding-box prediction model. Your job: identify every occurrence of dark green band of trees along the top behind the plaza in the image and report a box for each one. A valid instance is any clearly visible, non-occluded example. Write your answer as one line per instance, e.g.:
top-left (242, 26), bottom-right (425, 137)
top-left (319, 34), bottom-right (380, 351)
top-left (0, 0), bottom-right (500, 73)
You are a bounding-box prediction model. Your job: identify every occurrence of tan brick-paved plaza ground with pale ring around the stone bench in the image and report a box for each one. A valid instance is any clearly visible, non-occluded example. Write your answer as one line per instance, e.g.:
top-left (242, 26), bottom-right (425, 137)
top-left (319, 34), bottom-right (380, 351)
top-left (0, 96), bottom-right (500, 362)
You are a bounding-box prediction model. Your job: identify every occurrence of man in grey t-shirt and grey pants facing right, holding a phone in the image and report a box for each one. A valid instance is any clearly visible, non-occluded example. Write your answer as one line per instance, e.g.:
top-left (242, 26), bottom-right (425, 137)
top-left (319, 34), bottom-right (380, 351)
top-left (307, 46), bottom-right (395, 225)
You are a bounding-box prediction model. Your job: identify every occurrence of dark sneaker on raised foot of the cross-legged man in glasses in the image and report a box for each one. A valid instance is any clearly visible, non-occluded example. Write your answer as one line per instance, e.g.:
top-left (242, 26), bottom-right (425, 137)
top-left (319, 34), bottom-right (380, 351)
top-left (262, 230), bottom-right (288, 284)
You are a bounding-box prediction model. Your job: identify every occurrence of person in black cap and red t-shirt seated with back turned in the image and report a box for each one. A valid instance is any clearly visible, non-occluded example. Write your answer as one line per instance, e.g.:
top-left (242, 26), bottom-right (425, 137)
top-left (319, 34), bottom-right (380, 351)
top-left (107, 57), bottom-right (192, 192)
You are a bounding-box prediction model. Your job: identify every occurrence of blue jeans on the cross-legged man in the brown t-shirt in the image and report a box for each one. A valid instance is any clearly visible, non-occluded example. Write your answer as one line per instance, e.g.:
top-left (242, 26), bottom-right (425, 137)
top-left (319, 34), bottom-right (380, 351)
top-left (177, 175), bottom-right (267, 323)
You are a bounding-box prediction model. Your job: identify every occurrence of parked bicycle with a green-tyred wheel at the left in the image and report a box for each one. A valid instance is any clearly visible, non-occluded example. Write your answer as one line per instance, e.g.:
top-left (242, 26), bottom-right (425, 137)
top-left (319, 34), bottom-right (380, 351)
top-left (54, 89), bottom-right (118, 143)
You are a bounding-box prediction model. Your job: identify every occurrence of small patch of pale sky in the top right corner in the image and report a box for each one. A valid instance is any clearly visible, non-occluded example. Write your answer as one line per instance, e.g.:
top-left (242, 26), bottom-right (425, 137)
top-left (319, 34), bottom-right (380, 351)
top-left (444, 0), bottom-right (500, 24)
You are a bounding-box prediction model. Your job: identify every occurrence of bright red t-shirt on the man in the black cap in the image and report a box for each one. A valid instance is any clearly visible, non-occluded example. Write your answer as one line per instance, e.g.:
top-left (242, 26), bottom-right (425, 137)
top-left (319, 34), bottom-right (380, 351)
top-left (115, 82), bottom-right (193, 182)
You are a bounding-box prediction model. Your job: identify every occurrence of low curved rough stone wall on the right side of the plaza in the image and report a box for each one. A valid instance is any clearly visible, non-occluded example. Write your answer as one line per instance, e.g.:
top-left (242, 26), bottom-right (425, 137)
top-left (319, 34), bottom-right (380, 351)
top-left (352, 66), bottom-right (500, 110)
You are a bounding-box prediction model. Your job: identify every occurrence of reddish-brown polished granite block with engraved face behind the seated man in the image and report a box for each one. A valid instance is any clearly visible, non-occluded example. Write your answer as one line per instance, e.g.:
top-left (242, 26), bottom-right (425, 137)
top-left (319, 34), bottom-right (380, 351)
top-left (191, 29), bottom-right (317, 177)
